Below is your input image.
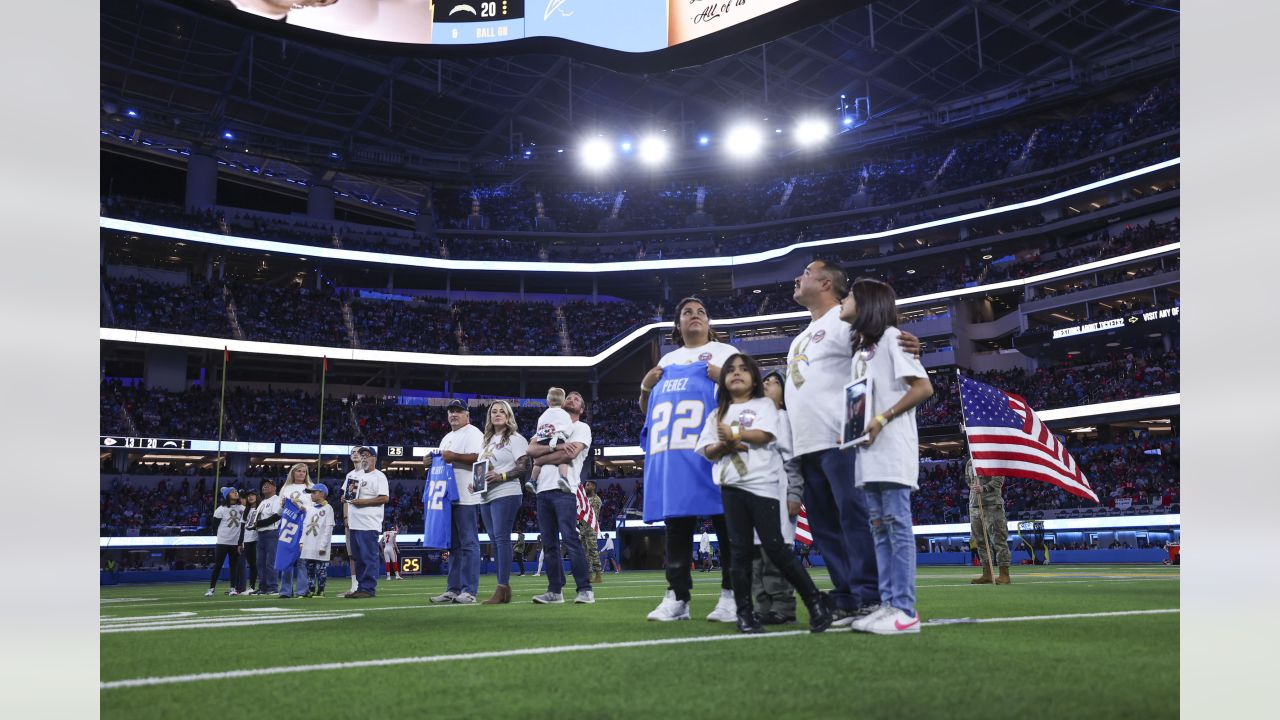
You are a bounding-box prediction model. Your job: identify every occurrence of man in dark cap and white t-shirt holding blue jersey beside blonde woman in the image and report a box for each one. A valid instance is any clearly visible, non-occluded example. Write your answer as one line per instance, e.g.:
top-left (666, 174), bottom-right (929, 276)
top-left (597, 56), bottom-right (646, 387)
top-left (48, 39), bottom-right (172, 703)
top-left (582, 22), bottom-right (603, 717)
top-left (426, 400), bottom-right (484, 605)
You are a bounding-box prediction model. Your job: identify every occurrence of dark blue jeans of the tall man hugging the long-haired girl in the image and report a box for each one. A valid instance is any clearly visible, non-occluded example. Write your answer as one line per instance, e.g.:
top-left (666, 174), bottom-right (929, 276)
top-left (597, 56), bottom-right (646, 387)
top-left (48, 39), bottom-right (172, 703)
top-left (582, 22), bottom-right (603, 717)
top-left (799, 447), bottom-right (879, 610)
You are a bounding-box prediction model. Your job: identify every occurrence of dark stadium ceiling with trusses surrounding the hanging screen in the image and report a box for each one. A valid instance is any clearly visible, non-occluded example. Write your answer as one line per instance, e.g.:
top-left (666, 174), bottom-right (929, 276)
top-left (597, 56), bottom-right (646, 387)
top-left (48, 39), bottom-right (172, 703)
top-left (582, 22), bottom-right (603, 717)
top-left (100, 0), bottom-right (1179, 179)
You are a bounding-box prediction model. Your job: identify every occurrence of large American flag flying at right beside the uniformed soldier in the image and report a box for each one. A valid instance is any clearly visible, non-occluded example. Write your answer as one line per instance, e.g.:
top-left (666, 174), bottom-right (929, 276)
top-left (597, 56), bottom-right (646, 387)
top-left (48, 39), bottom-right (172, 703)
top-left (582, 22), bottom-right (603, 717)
top-left (960, 375), bottom-right (1098, 502)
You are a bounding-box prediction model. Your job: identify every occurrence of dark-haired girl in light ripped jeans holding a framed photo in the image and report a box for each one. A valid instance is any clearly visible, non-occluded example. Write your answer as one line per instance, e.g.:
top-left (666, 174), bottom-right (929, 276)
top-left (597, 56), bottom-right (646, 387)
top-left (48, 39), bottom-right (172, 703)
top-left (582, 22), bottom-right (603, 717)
top-left (840, 278), bottom-right (933, 635)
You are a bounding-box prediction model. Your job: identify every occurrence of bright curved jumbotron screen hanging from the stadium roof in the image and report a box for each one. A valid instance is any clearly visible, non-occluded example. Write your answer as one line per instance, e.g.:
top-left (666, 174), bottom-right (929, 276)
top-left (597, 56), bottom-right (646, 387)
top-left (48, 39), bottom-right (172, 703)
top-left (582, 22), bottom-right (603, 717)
top-left (214, 0), bottom-right (797, 53)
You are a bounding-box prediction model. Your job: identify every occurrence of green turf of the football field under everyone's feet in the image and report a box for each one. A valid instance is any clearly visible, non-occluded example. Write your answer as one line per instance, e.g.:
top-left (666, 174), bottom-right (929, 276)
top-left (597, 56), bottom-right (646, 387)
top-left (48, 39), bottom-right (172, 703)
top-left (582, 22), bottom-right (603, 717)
top-left (101, 566), bottom-right (1179, 720)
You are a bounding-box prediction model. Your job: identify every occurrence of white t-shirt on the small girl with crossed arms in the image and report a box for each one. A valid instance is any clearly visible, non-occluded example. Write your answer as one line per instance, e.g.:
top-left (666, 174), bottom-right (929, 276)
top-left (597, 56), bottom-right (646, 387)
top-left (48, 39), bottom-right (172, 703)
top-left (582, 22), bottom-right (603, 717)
top-left (695, 397), bottom-right (783, 497)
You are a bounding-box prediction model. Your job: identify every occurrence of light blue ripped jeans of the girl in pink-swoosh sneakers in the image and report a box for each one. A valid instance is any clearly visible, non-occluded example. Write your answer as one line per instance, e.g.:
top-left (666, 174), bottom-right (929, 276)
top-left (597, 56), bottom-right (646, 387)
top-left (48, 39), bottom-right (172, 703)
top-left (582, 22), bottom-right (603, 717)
top-left (863, 483), bottom-right (915, 615)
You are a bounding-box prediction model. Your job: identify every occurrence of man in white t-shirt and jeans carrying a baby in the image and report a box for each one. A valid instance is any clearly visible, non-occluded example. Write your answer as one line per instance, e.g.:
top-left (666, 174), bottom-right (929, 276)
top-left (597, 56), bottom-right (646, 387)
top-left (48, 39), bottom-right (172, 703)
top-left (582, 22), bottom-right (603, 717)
top-left (529, 392), bottom-right (595, 605)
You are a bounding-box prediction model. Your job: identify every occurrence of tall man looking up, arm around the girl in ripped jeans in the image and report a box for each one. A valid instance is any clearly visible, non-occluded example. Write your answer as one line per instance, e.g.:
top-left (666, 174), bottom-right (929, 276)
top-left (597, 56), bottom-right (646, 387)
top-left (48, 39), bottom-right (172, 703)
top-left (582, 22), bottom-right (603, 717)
top-left (785, 260), bottom-right (920, 626)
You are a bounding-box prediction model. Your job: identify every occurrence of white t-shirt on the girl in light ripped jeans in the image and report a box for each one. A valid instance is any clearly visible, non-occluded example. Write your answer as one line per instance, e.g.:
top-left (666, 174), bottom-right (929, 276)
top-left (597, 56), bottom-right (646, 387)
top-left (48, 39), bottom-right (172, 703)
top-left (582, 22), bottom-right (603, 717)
top-left (851, 325), bottom-right (929, 489)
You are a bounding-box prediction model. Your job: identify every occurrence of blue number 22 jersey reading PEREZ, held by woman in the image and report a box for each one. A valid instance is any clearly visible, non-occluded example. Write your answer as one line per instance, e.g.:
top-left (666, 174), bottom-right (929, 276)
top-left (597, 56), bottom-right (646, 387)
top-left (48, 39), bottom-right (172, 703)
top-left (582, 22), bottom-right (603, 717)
top-left (640, 363), bottom-right (724, 523)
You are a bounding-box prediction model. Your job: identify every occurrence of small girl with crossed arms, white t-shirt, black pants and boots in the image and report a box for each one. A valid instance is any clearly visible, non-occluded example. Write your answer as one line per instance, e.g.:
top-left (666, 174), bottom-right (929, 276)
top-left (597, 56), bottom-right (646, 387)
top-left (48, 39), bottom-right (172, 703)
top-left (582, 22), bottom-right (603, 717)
top-left (696, 354), bottom-right (832, 633)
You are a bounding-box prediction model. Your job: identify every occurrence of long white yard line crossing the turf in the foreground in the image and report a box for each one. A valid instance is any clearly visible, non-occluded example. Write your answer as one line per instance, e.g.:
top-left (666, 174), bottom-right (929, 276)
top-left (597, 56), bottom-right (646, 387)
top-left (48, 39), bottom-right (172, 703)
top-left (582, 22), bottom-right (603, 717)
top-left (99, 607), bottom-right (1180, 691)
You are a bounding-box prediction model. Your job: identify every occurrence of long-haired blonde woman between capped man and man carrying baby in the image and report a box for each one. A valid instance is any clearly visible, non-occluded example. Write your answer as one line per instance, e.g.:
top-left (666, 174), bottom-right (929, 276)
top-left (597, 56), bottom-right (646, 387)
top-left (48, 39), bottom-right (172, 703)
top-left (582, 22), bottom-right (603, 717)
top-left (472, 400), bottom-right (529, 605)
